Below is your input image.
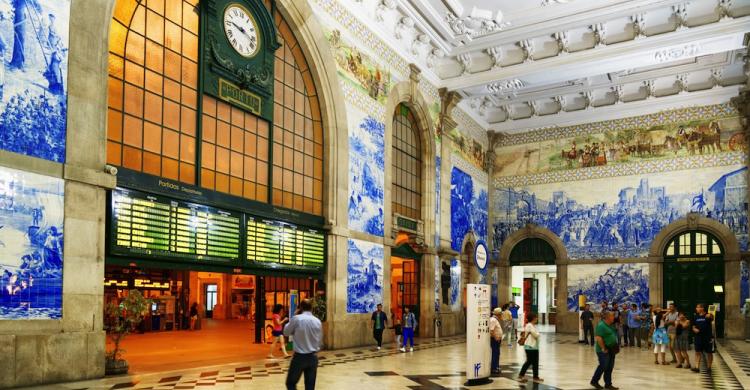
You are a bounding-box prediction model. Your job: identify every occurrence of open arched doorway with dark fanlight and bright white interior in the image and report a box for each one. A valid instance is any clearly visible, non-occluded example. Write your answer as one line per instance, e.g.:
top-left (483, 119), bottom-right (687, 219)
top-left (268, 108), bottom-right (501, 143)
top-left (509, 237), bottom-right (557, 325)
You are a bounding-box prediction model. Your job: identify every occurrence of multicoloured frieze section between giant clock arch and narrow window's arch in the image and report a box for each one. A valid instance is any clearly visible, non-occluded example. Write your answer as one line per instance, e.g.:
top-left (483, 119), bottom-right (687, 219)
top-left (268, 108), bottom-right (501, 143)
top-left (327, 30), bottom-right (391, 104)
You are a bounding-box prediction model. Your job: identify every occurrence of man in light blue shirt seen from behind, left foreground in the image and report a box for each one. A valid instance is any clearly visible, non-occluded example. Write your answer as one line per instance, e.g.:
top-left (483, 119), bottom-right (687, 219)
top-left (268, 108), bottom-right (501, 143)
top-left (284, 299), bottom-right (323, 390)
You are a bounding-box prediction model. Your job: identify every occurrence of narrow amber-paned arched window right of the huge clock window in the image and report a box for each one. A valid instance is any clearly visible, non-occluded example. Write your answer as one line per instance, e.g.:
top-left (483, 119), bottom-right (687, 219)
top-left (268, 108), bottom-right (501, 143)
top-left (391, 104), bottom-right (422, 220)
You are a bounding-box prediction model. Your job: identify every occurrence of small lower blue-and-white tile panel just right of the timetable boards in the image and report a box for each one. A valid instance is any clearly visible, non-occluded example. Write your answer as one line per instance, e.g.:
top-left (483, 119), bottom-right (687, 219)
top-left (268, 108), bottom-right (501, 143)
top-left (346, 238), bottom-right (384, 313)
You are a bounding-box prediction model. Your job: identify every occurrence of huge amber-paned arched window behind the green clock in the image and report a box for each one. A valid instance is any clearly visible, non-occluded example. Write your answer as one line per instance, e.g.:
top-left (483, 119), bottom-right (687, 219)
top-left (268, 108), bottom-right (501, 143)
top-left (107, 0), bottom-right (323, 215)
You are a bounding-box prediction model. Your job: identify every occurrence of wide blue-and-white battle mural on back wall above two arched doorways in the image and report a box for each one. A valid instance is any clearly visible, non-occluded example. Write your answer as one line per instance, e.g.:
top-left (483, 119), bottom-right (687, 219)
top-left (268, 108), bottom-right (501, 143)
top-left (493, 165), bottom-right (748, 259)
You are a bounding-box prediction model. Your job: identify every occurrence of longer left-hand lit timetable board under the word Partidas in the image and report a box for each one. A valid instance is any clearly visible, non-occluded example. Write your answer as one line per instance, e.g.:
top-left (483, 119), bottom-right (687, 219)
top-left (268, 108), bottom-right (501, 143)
top-left (112, 189), bottom-right (242, 261)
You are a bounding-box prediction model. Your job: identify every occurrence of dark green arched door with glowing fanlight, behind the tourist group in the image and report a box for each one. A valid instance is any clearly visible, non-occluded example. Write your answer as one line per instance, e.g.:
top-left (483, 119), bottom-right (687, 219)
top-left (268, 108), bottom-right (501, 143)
top-left (663, 230), bottom-right (725, 337)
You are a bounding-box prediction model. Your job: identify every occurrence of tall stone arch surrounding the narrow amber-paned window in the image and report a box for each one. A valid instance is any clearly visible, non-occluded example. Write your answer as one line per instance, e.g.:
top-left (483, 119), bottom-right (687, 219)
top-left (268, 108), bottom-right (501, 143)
top-left (384, 81), bottom-right (436, 243)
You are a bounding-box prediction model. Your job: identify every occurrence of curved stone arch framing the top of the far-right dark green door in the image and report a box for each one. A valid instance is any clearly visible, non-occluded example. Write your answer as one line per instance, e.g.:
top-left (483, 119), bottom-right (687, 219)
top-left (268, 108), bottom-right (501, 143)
top-left (648, 213), bottom-right (740, 261)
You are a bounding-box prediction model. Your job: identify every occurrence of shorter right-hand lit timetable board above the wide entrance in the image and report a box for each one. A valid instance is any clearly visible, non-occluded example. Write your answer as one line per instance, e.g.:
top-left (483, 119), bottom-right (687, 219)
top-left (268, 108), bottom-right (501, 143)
top-left (247, 216), bottom-right (325, 268)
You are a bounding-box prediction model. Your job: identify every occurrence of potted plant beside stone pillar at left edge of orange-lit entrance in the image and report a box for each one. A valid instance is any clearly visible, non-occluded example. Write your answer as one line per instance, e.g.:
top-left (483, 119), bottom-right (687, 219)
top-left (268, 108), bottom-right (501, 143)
top-left (104, 290), bottom-right (151, 375)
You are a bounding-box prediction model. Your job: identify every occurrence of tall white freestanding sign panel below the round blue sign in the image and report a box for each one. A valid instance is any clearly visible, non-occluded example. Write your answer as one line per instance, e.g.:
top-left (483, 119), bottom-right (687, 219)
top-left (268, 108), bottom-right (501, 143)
top-left (466, 284), bottom-right (492, 385)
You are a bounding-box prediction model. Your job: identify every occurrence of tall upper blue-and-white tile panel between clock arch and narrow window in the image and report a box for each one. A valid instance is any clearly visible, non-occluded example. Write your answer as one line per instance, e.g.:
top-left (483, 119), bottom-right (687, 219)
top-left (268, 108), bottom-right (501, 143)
top-left (349, 116), bottom-right (385, 237)
